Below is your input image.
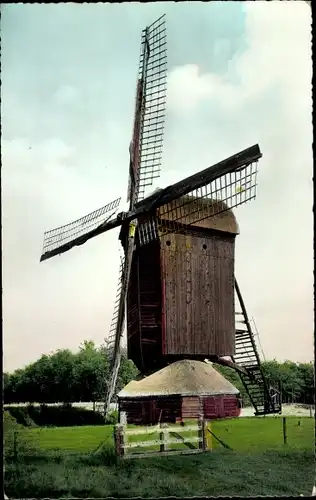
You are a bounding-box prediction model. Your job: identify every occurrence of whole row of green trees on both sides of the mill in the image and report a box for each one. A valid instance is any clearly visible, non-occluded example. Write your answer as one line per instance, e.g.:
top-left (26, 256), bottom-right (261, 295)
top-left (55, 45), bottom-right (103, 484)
top-left (3, 341), bottom-right (314, 404)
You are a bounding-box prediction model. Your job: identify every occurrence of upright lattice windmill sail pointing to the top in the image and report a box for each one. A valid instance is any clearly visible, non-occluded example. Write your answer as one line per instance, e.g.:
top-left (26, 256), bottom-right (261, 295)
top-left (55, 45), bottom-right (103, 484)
top-left (128, 15), bottom-right (167, 209)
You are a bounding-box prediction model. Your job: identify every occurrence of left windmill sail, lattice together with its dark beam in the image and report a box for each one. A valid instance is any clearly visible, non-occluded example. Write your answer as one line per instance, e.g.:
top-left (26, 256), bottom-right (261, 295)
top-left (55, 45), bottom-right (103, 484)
top-left (40, 198), bottom-right (121, 261)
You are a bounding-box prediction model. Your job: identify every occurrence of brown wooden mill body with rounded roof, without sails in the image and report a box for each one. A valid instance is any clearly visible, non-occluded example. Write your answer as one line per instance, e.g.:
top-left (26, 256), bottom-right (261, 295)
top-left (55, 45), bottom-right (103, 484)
top-left (127, 197), bottom-right (238, 373)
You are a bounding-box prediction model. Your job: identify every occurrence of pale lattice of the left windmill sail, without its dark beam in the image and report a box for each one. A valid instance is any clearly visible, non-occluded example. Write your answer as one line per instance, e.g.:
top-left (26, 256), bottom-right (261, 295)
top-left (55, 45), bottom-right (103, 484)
top-left (42, 198), bottom-right (121, 255)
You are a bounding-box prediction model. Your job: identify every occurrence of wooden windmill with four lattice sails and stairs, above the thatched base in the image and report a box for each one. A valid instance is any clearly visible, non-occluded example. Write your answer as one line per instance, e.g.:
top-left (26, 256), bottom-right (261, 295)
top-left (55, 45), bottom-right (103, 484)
top-left (41, 16), bottom-right (280, 414)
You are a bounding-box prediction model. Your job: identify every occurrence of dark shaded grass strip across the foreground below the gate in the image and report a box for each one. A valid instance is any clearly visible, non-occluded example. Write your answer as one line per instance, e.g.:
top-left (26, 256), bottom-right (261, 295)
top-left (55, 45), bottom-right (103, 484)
top-left (5, 446), bottom-right (314, 498)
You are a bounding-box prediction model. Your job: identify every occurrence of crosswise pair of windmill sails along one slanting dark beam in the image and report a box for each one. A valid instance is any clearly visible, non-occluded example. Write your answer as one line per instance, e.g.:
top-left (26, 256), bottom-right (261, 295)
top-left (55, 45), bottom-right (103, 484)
top-left (41, 145), bottom-right (262, 261)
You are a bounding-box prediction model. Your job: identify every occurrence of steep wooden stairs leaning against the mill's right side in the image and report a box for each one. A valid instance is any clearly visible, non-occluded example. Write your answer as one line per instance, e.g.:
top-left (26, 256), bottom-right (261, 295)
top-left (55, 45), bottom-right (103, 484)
top-left (231, 279), bottom-right (282, 416)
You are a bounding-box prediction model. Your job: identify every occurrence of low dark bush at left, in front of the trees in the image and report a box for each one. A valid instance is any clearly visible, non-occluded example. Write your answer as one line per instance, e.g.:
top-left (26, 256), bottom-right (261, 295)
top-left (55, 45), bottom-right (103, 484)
top-left (6, 404), bottom-right (105, 427)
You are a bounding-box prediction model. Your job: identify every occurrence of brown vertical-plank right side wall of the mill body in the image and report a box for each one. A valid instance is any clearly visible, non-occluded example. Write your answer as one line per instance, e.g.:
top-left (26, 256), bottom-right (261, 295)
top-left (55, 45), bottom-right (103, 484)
top-left (161, 231), bottom-right (235, 356)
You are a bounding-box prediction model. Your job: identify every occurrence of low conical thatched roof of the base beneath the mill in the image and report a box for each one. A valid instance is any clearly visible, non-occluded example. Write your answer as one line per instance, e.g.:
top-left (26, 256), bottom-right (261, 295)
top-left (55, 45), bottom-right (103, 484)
top-left (118, 359), bottom-right (239, 398)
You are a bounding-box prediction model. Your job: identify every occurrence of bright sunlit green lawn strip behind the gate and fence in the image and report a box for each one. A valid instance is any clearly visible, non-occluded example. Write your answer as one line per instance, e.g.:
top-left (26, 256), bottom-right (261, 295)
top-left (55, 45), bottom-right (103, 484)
top-left (22, 417), bottom-right (314, 452)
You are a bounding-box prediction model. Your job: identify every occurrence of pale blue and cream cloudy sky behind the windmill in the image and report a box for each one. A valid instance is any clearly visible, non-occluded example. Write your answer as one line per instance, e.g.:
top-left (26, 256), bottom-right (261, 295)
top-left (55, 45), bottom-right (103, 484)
top-left (1, 1), bottom-right (314, 371)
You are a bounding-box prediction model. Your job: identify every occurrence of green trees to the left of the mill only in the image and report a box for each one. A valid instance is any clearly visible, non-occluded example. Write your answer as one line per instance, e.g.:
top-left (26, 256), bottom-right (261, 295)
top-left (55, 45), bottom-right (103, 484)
top-left (3, 341), bottom-right (138, 404)
